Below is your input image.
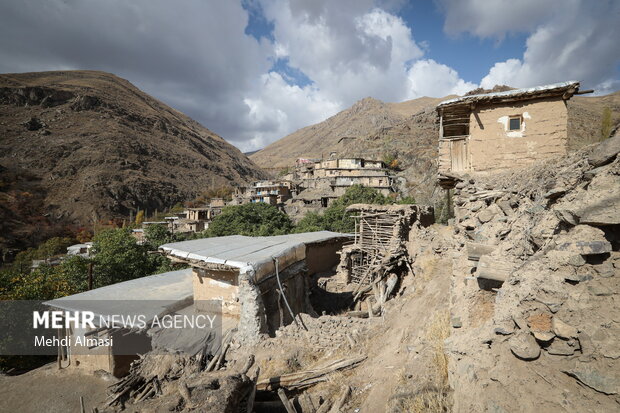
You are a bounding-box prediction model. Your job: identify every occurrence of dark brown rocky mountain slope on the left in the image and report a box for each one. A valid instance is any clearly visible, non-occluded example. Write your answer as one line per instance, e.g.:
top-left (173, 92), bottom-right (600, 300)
top-left (0, 71), bottom-right (266, 251)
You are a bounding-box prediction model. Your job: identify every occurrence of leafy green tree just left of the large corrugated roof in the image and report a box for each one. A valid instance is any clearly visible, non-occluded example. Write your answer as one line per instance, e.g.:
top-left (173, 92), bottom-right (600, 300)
top-left (93, 228), bottom-right (154, 288)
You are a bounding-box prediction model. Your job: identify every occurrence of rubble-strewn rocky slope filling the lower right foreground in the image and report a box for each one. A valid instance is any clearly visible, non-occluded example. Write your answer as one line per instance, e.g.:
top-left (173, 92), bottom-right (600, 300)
top-left (2, 135), bottom-right (620, 413)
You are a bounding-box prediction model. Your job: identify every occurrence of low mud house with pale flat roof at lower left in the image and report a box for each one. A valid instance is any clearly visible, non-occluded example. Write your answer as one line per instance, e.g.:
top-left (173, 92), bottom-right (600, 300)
top-left (43, 269), bottom-right (193, 377)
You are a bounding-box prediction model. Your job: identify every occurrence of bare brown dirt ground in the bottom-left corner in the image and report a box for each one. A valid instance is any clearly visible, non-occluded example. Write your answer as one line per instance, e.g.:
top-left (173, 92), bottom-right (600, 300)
top-left (0, 363), bottom-right (110, 413)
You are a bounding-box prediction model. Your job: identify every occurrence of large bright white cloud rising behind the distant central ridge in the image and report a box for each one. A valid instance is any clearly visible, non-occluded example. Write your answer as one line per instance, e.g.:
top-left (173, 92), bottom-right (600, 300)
top-left (236, 0), bottom-right (476, 147)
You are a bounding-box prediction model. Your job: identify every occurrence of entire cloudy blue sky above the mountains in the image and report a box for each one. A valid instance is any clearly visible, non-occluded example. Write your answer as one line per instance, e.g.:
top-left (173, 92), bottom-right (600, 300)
top-left (0, 0), bottom-right (620, 151)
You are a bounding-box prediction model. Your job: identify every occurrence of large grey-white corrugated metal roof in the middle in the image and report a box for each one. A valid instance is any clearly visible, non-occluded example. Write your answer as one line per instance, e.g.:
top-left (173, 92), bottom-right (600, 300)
top-left (159, 231), bottom-right (352, 269)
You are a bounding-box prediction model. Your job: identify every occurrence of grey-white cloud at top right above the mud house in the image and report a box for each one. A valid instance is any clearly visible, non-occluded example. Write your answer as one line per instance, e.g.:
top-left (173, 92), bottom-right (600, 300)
top-left (441, 0), bottom-right (620, 93)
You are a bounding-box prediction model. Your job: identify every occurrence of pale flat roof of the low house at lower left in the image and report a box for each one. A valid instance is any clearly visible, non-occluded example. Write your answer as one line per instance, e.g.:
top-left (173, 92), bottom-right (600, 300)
top-left (43, 268), bottom-right (194, 327)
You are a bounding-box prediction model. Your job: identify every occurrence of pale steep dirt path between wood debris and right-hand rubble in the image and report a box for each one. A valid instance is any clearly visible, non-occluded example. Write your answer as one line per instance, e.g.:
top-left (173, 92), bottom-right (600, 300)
top-left (352, 249), bottom-right (451, 413)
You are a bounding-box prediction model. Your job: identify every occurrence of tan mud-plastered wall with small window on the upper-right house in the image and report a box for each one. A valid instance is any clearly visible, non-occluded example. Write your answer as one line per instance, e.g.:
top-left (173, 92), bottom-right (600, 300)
top-left (470, 98), bottom-right (568, 172)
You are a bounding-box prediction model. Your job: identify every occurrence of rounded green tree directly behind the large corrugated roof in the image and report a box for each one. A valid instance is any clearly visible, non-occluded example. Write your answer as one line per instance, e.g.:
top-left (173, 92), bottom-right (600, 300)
top-left (203, 202), bottom-right (293, 237)
